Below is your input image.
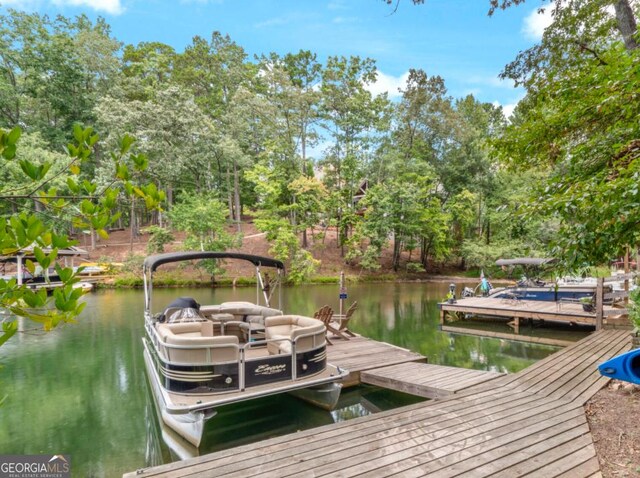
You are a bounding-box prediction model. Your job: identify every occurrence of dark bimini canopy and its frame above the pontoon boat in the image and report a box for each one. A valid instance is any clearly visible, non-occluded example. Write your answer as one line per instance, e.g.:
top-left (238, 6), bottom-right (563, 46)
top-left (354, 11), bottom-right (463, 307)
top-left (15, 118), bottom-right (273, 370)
top-left (142, 251), bottom-right (285, 314)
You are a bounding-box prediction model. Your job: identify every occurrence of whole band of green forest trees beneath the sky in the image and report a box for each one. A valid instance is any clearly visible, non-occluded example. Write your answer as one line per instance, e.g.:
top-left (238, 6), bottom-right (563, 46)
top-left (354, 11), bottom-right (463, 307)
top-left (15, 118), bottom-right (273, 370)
top-left (0, 0), bottom-right (640, 288)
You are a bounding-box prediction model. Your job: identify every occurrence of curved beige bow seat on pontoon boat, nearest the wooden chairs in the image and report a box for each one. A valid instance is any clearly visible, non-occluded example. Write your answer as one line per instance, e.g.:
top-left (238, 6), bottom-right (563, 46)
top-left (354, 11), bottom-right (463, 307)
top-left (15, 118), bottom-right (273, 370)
top-left (265, 315), bottom-right (326, 355)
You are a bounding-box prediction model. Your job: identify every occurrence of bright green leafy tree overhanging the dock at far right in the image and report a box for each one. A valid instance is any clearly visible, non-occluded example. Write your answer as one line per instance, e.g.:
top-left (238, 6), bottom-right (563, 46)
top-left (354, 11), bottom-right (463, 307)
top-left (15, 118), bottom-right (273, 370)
top-left (495, 1), bottom-right (640, 269)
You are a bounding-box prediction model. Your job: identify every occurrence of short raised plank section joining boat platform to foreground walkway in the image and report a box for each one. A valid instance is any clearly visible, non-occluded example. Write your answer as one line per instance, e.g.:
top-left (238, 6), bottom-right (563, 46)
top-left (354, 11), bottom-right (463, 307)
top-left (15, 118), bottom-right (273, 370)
top-left (360, 362), bottom-right (505, 398)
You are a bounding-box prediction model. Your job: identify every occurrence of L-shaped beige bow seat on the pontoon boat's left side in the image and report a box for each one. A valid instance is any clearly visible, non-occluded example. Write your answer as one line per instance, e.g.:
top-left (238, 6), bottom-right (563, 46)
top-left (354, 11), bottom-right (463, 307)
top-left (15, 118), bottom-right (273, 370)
top-left (158, 321), bottom-right (239, 364)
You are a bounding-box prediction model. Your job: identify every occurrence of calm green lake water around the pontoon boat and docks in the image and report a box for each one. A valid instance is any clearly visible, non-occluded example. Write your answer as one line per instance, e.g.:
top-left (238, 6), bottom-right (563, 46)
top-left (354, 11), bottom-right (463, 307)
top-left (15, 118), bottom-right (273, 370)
top-left (0, 283), bottom-right (580, 477)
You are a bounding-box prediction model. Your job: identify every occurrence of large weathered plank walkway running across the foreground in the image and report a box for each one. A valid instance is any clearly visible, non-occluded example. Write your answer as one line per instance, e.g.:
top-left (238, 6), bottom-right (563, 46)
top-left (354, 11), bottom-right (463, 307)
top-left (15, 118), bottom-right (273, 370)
top-left (126, 330), bottom-right (629, 478)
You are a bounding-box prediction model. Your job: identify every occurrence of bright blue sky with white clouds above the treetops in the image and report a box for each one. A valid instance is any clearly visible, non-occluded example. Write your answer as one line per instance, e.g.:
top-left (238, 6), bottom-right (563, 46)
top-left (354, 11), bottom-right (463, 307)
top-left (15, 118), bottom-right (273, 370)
top-left (0, 0), bottom-right (549, 115)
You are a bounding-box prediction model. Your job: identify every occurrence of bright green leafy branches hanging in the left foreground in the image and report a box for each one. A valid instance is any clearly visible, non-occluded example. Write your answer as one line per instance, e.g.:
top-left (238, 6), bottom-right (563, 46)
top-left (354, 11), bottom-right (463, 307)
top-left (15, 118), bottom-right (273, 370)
top-left (0, 125), bottom-right (163, 345)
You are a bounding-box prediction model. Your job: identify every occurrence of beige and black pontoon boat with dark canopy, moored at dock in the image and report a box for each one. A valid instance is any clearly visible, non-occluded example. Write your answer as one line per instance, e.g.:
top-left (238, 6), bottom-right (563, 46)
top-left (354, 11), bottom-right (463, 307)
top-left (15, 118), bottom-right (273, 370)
top-left (143, 252), bottom-right (348, 447)
